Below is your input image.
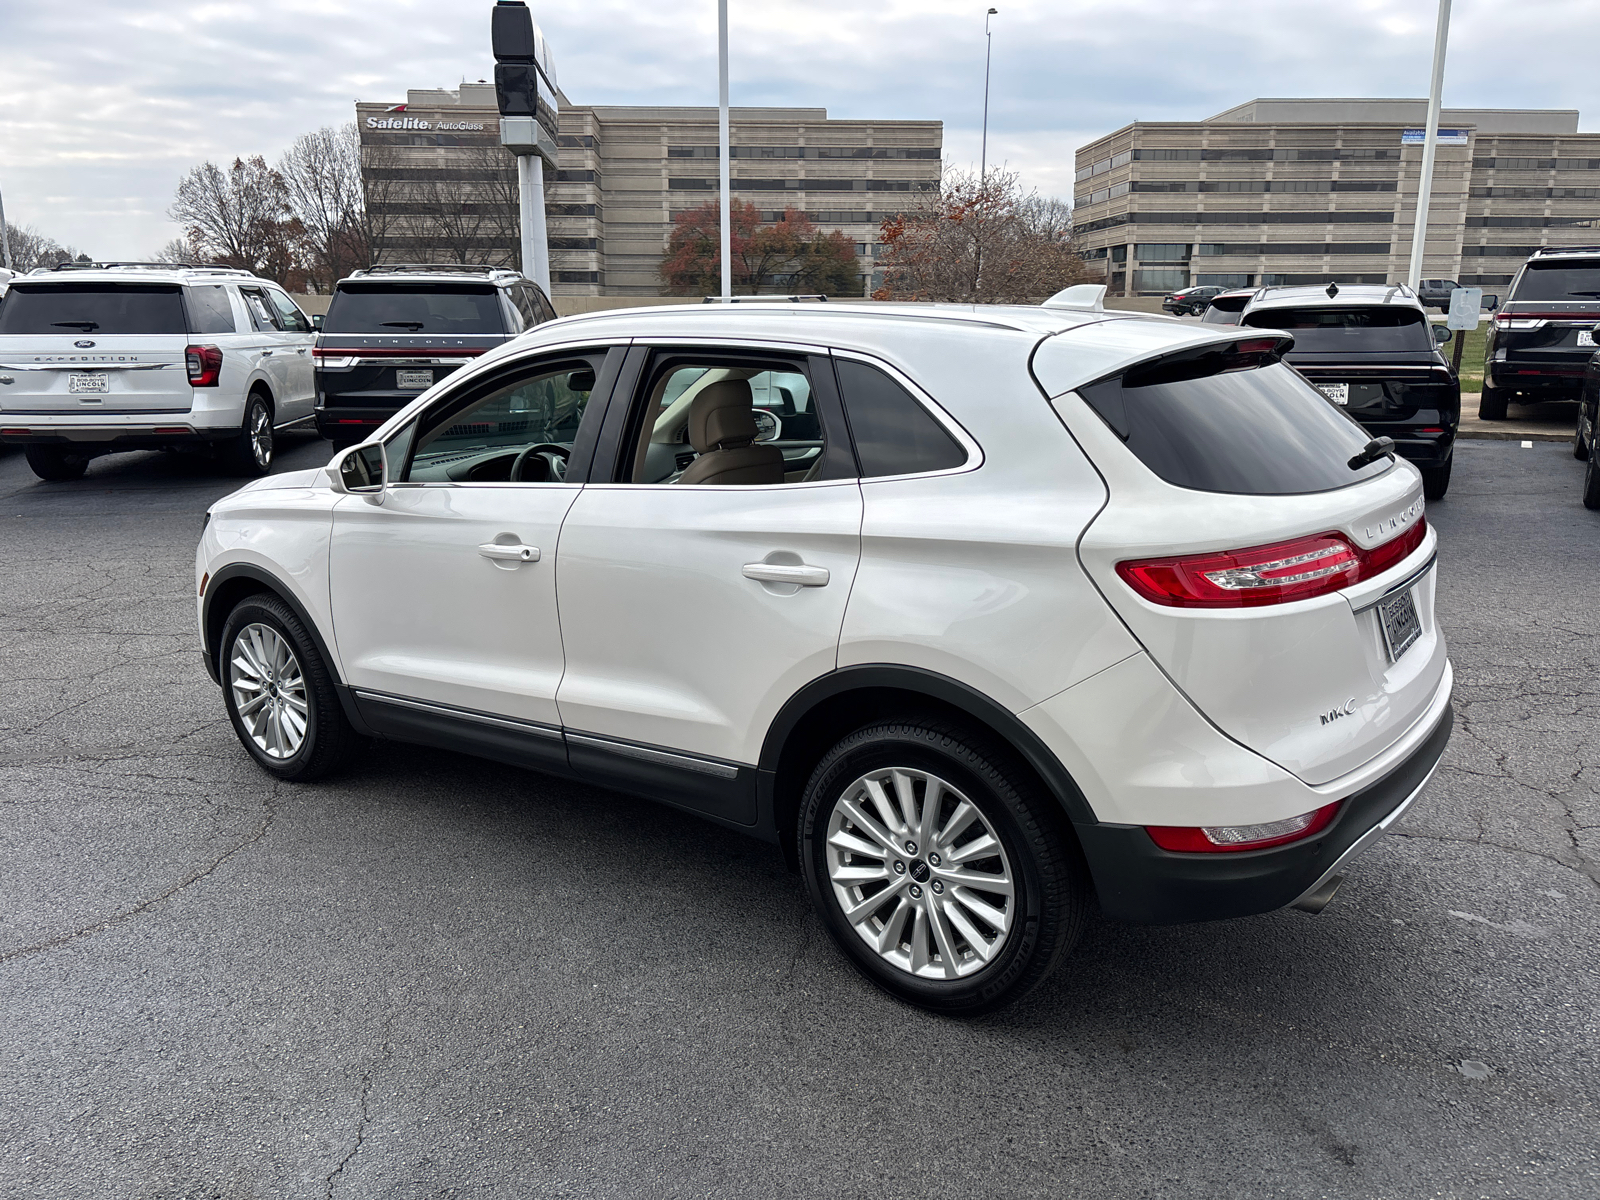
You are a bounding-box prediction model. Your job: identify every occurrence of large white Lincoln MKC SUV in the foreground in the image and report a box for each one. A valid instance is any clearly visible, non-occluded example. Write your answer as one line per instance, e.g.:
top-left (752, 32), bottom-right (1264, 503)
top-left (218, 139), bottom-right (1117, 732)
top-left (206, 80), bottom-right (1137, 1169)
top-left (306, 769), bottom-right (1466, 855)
top-left (195, 299), bottom-right (1451, 1014)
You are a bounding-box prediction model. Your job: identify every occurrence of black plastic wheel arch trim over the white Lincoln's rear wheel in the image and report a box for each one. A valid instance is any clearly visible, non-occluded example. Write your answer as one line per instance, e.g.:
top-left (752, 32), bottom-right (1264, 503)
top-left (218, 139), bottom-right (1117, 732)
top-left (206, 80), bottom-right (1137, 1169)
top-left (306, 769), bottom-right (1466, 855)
top-left (757, 664), bottom-right (1096, 869)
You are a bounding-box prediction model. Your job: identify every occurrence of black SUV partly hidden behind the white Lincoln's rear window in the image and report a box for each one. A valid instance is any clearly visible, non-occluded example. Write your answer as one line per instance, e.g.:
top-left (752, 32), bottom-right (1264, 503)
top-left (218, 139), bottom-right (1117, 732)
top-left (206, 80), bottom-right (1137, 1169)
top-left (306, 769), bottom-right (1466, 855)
top-left (1240, 283), bottom-right (1461, 501)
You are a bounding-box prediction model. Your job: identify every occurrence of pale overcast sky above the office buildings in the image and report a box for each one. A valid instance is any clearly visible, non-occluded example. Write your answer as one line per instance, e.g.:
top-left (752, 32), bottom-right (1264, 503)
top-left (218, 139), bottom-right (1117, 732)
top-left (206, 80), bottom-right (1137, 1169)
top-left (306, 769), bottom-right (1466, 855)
top-left (0, 0), bottom-right (1600, 258)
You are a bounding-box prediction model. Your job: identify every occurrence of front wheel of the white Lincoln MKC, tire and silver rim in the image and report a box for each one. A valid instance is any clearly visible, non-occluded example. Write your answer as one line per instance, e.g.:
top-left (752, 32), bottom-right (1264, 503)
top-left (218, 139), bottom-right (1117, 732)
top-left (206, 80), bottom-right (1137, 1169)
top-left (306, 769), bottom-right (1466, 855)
top-left (218, 595), bottom-right (358, 782)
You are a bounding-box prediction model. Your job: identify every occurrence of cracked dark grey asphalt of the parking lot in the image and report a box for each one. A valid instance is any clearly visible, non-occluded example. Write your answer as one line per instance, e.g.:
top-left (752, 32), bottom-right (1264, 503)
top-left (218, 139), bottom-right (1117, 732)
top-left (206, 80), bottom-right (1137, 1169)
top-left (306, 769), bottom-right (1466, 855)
top-left (0, 438), bottom-right (1600, 1200)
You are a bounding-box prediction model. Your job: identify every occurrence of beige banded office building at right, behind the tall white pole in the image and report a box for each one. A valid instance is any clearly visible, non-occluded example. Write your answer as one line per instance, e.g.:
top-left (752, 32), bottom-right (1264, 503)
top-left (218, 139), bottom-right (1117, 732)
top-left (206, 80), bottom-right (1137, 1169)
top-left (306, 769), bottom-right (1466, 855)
top-left (1074, 99), bottom-right (1600, 294)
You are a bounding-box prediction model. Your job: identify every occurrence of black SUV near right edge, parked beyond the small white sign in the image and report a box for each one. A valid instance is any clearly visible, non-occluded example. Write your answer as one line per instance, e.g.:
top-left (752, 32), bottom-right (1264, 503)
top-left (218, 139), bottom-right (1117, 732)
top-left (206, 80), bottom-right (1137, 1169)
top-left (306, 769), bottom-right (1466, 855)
top-left (1478, 246), bottom-right (1600, 421)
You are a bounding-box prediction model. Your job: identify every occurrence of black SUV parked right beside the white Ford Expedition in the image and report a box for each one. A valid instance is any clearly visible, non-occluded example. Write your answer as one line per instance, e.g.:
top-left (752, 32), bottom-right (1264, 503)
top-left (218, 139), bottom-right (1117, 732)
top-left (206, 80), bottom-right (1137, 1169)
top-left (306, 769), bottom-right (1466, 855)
top-left (312, 264), bottom-right (555, 448)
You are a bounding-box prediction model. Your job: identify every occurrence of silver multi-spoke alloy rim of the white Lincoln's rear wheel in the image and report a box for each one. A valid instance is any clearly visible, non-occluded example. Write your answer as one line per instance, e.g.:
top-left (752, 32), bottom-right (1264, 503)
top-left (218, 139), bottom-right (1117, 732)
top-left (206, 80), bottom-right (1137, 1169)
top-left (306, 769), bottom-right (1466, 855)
top-left (827, 766), bottom-right (1018, 979)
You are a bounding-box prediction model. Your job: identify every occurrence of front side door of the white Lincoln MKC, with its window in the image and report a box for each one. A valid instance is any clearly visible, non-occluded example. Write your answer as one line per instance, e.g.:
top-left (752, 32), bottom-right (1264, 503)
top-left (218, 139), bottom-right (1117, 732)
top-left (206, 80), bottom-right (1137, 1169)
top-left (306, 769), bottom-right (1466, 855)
top-left (330, 349), bottom-right (621, 768)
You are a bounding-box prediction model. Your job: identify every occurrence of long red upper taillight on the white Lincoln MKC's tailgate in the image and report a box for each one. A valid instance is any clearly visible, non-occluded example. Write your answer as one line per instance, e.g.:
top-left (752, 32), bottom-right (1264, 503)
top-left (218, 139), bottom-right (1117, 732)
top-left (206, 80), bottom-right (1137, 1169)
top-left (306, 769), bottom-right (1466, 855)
top-left (1117, 518), bottom-right (1427, 608)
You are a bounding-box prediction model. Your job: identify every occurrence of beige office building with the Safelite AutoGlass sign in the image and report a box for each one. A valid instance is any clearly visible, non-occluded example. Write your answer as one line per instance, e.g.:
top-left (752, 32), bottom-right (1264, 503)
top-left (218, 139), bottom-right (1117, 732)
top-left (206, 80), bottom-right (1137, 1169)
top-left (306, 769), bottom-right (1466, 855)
top-left (355, 83), bottom-right (944, 296)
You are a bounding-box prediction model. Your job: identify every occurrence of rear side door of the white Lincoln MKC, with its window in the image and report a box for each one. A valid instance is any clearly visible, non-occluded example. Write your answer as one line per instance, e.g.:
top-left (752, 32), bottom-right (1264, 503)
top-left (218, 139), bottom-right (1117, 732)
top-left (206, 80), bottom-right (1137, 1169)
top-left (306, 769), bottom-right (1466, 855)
top-left (557, 346), bottom-right (861, 824)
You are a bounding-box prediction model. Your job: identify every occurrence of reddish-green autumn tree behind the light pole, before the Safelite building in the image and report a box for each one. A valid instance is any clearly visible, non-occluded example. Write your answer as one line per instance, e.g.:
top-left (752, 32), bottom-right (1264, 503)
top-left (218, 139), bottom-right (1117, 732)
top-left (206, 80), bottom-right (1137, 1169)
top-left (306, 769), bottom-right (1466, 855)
top-left (659, 200), bottom-right (861, 296)
